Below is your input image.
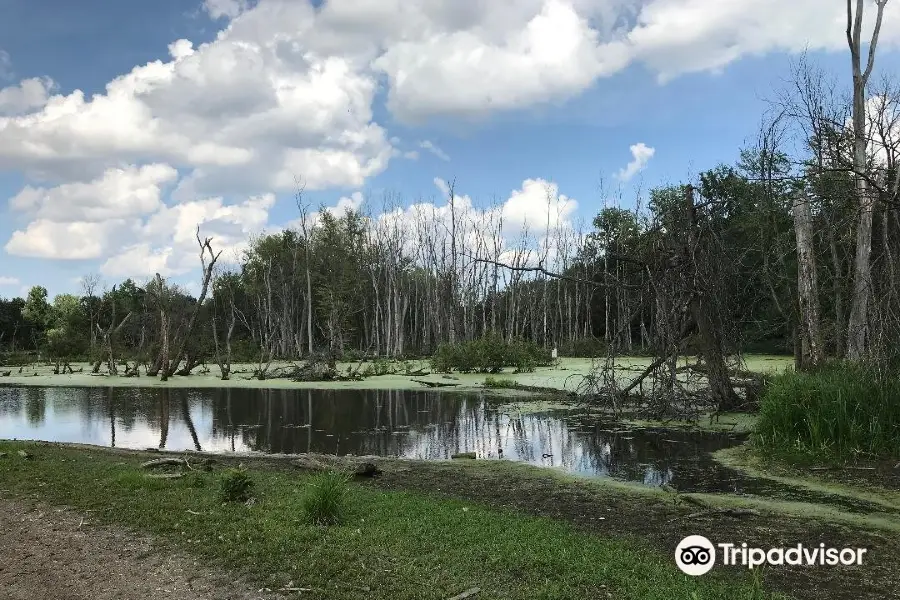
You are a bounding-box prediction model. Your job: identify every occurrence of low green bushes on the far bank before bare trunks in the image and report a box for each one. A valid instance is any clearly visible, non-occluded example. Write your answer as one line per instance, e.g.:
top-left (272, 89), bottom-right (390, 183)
top-left (431, 333), bottom-right (551, 373)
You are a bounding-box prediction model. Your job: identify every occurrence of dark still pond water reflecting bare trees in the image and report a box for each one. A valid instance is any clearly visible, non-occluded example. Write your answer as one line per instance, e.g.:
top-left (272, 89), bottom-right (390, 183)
top-left (0, 387), bottom-right (741, 491)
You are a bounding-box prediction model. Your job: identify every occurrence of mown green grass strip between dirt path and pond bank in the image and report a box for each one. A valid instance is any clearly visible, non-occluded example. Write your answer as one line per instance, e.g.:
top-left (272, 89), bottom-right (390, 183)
top-left (0, 442), bottom-right (788, 600)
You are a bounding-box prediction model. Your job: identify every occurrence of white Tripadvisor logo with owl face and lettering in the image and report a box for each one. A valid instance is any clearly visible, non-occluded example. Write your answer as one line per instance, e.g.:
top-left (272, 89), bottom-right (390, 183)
top-left (675, 535), bottom-right (866, 576)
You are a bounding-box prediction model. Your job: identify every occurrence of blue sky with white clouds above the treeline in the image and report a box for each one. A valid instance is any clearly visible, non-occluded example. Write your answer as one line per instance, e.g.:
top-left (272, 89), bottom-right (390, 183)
top-left (0, 0), bottom-right (900, 297)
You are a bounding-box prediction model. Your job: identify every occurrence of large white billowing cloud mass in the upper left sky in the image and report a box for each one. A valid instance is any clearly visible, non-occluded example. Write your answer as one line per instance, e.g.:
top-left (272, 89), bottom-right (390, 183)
top-left (0, 15), bottom-right (392, 191)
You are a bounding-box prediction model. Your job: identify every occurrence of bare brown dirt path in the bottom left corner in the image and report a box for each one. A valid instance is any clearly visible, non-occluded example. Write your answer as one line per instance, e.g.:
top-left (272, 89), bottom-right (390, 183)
top-left (0, 500), bottom-right (282, 600)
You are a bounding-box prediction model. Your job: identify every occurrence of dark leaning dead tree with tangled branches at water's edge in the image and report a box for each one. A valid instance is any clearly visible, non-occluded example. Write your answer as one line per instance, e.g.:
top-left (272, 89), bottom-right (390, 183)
top-left (473, 185), bottom-right (740, 417)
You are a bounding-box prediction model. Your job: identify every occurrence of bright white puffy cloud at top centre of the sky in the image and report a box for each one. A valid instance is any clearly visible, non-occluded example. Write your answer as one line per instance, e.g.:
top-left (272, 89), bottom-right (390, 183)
top-left (373, 0), bottom-right (628, 121)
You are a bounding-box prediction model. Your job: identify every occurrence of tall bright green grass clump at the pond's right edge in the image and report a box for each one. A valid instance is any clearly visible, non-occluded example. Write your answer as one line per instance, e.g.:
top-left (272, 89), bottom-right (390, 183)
top-left (755, 362), bottom-right (900, 458)
